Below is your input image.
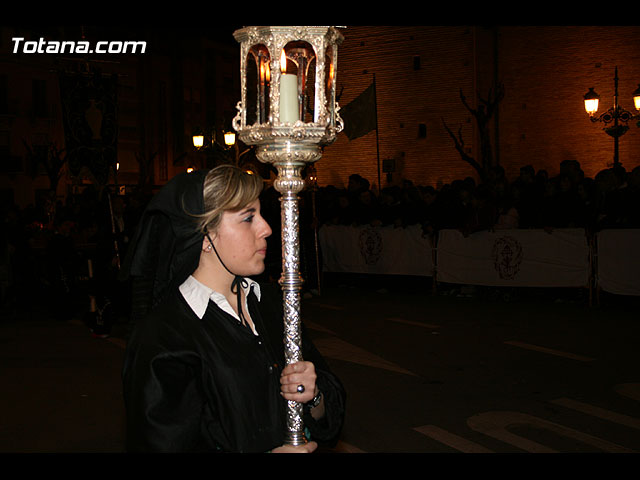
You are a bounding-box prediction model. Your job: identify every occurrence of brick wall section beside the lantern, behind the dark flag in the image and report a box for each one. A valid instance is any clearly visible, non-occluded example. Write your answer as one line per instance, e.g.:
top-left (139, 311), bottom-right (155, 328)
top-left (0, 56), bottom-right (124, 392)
top-left (317, 27), bottom-right (473, 186)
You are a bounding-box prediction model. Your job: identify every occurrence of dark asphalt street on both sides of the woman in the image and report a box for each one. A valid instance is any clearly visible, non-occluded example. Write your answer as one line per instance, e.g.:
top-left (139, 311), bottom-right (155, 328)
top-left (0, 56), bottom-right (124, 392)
top-left (0, 277), bottom-right (640, 453)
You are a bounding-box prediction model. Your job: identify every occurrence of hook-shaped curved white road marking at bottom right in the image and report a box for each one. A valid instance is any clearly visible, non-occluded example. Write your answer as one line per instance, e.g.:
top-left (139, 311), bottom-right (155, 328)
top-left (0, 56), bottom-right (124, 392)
top-left (467, 411), bottom-right (634, 453)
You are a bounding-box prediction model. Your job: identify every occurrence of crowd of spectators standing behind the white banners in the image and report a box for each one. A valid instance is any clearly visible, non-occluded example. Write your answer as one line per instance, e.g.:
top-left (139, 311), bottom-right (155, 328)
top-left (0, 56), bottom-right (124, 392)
top-left (308, 160), bottom-right (640, 234)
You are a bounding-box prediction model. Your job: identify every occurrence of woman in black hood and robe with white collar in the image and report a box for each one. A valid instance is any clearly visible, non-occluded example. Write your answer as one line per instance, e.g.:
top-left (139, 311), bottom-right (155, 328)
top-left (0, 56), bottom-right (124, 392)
top-left (123, 165), bottom-right (345, 452)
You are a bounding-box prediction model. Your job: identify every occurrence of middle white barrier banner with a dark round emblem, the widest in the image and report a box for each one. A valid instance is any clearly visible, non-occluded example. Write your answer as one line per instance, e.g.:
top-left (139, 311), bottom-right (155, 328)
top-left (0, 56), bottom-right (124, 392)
top-left (437, 229), bottom-right (590, 287)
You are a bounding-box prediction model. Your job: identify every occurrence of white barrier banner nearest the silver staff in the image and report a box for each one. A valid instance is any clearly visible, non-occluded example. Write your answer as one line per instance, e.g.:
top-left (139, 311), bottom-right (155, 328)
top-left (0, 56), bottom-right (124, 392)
top-left (318, 225), bottom-right (433, 276)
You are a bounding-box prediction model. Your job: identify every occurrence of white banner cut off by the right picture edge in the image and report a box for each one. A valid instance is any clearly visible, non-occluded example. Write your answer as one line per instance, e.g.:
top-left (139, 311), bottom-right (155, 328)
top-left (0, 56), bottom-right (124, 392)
top-left (596, 229), bottom-right (640, 295)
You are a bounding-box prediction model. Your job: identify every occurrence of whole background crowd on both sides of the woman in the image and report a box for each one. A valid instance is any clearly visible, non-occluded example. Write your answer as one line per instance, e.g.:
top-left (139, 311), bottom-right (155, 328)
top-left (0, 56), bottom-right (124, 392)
top-left (0, 161), bottom-right (640, 318)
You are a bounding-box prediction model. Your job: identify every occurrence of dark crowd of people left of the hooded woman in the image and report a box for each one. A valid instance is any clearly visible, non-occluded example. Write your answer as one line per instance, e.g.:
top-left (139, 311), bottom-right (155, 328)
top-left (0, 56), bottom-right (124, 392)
top-left (0, 185), bottom-right (150, 326)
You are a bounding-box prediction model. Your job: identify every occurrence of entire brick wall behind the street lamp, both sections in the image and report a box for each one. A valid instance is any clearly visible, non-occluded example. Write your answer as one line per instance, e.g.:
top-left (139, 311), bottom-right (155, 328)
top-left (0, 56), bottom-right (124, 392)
top-left (317, 26), bottom-right (640, 186)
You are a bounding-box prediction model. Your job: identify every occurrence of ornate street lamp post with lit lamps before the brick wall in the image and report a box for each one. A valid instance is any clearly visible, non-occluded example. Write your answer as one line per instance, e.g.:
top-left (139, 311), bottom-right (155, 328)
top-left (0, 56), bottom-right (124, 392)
top-left (584, 67), bottom-right (640, 168)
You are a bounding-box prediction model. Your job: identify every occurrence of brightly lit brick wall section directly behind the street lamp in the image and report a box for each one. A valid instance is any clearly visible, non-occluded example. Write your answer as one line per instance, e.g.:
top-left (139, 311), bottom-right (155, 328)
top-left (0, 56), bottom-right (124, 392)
top-left (499, 26), bottom-right (640, 177)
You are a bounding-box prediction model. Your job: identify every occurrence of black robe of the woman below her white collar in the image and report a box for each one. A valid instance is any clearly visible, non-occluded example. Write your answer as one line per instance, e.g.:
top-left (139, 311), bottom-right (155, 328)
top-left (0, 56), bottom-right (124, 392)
top-left (123, 285), bottom-right (345, 452)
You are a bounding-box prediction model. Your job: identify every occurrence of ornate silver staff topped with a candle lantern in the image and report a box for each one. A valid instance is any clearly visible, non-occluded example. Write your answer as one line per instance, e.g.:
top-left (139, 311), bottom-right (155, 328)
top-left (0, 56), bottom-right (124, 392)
top-left (233, 26), bottom-right (343, 445)
